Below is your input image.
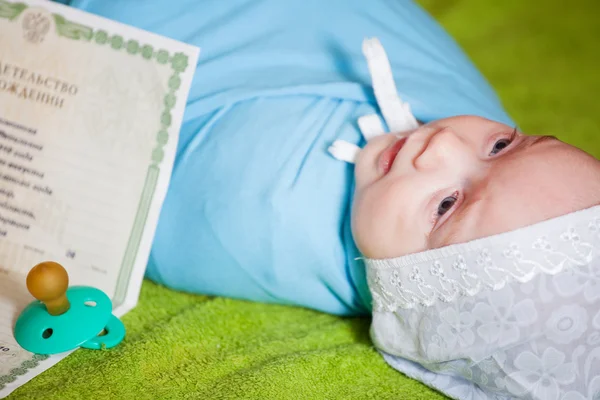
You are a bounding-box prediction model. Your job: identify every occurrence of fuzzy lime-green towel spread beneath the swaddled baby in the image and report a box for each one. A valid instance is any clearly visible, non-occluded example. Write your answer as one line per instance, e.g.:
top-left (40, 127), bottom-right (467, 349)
top-left (9, 0), bottom-right (600, 400)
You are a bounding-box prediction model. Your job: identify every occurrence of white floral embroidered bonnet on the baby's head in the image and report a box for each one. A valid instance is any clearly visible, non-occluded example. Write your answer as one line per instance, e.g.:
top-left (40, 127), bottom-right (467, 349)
top-left (365, 206), bottom-right (600, 400)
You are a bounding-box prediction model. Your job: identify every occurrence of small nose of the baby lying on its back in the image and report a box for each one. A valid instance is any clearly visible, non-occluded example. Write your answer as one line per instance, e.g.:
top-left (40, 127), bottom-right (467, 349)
top-left (415, 127), bottom-right (471, 169)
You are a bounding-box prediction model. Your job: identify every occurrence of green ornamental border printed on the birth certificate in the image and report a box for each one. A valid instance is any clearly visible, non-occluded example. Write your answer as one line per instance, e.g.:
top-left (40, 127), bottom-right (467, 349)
top-left (0, 0), bottom-right (189, 390)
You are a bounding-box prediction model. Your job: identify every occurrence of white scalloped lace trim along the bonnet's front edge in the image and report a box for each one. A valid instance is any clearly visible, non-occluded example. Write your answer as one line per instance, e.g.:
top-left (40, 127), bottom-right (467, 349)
top-left (365, 206), bottom-right (600, 312)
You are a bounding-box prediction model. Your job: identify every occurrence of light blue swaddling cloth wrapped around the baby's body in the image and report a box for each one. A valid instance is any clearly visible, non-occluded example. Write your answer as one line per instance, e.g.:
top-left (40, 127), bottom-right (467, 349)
top-left (62, 0), bottom-right (512, 315)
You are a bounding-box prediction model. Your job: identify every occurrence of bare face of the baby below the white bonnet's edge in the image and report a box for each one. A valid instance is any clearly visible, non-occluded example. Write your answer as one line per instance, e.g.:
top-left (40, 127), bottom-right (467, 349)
top-left (352, 116), bottom-right (600, 258)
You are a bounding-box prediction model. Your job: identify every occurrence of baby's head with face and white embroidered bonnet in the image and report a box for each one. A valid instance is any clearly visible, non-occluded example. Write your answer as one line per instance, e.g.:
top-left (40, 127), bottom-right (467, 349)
top-left (346, 39), bottom-right (600, 400)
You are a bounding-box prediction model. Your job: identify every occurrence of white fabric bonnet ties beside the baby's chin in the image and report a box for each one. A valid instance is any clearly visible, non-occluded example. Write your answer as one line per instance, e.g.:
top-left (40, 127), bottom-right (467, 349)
top-left (327, 38), bottom-right (419, 164)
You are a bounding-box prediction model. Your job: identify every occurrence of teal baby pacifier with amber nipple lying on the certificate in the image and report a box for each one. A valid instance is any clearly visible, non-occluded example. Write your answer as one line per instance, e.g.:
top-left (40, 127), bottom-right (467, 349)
top-left (14, 262), bottom-right (125, 354)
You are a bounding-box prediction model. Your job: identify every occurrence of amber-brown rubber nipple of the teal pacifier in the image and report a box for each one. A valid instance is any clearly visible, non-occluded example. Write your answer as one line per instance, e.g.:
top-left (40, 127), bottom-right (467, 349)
top-left (27, 261), bottom-right (71, 315)
